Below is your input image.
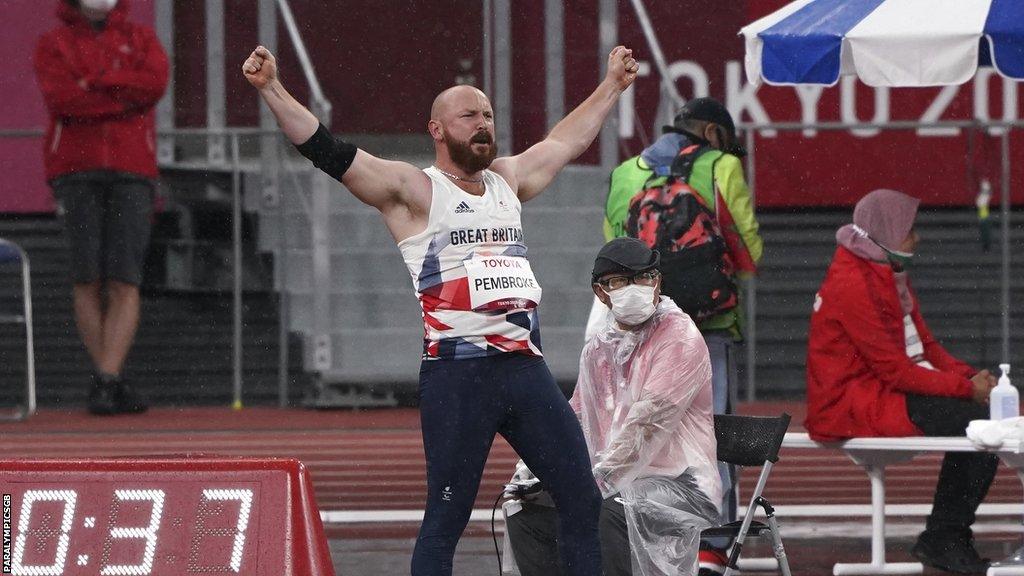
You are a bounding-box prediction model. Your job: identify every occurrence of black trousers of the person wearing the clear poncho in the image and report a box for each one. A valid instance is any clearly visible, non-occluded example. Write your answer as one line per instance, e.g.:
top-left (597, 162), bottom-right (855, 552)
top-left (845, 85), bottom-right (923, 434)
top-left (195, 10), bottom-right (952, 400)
top-left (506, 496), bottom-right (633, 576)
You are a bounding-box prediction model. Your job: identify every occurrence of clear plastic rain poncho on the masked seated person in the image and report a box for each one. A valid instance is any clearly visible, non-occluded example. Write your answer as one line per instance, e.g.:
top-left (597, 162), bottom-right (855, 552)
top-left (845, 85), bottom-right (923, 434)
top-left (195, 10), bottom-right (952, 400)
top-left (570, 296), bottom-right (722, 576)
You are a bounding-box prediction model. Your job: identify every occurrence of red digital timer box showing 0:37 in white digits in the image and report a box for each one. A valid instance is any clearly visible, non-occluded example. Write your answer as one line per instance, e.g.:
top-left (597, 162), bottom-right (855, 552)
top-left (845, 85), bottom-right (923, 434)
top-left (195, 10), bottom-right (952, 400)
top-left (0, 458), bottom-right (334, 576)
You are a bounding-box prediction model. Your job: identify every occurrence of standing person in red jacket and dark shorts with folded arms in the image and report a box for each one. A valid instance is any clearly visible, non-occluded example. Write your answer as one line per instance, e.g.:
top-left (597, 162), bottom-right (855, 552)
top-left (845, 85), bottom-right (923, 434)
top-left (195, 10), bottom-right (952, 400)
top-left (35, 0), bottom-right (168, 414)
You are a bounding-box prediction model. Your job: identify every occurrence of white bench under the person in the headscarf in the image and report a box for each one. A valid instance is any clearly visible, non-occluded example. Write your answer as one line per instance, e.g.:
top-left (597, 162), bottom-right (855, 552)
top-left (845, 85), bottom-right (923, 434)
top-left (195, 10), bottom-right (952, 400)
top-left (782, 433), bottom-right (1024, 576)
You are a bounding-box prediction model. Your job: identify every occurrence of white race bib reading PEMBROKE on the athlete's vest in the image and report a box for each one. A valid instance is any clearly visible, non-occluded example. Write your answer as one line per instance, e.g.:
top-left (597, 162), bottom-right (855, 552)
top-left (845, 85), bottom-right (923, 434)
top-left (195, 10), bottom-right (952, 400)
top-left (466, 256), bottom-right (541, 311)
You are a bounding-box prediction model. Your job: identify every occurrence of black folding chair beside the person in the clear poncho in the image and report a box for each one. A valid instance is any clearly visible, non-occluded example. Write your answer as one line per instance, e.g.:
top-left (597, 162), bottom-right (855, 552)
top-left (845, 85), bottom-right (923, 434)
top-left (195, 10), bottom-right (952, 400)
top-left (702, 414), bottom-right (791, 576)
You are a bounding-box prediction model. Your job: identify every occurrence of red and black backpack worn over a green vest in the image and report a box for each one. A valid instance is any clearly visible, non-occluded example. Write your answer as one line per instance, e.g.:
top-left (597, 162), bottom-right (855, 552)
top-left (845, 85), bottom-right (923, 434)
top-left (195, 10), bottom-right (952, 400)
top-left (626, 145), bottom-right (736, 321)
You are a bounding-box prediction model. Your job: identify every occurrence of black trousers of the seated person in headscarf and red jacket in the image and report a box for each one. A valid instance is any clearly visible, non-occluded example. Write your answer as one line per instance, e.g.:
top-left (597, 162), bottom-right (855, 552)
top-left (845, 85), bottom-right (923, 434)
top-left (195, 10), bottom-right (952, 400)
top-left (906, 394), bottom-right (999, 537)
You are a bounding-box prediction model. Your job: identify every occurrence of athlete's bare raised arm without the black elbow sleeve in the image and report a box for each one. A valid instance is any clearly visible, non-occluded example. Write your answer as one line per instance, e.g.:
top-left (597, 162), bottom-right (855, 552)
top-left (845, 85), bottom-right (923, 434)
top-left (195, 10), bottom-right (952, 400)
top-left (494, 46), bottom-right (639, 202)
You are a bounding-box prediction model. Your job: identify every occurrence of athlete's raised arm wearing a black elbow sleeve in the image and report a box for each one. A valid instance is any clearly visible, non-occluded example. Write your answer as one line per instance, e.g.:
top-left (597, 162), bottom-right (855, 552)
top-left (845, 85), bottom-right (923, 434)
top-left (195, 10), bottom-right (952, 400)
top-left (242, 46), bottom-right (430, 217)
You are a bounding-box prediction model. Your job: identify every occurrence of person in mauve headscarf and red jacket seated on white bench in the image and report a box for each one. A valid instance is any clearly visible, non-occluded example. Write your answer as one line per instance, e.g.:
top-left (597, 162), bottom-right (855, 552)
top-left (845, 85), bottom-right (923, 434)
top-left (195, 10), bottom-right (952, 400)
top-left (805, 190), bottom-right (997, 573)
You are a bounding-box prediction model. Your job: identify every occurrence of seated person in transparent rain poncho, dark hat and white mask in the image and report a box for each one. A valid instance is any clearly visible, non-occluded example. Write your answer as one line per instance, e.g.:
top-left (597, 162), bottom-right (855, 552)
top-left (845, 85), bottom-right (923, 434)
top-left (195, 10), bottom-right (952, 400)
top-left (505, 238), bottom-right (722, 576)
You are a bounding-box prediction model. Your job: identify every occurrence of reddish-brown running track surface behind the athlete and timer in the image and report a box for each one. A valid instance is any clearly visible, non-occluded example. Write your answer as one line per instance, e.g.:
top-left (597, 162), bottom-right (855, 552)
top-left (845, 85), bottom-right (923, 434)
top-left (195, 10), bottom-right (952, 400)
top-left (0, 403), bottom-right (1022, 511)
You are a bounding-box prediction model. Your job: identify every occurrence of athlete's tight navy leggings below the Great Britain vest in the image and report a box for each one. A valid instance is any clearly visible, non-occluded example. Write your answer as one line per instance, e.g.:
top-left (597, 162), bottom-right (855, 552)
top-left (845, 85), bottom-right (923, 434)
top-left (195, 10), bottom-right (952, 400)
top-left (412, 354), bottom-right (601, 576)
